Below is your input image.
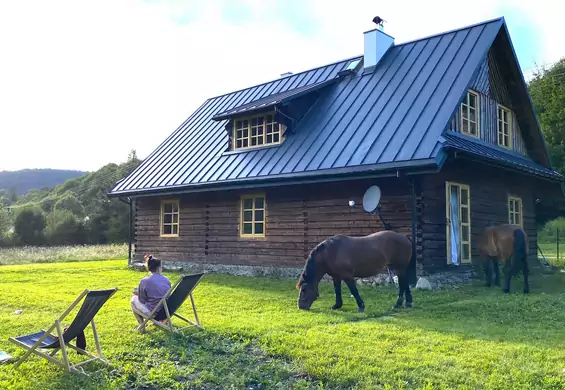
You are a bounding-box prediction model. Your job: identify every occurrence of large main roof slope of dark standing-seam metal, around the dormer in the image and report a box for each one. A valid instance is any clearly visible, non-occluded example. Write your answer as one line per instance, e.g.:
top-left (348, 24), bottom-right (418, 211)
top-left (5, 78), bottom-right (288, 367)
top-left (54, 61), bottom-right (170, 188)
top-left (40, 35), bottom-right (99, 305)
top-left (111, 18), bottom-right (556, 195)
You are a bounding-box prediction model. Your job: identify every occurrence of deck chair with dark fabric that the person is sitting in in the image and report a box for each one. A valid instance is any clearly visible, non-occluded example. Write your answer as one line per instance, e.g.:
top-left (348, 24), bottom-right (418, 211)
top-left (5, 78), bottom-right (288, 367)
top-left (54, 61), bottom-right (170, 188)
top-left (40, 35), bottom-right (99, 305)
top-left (133, 273), bottom-right (205, 333)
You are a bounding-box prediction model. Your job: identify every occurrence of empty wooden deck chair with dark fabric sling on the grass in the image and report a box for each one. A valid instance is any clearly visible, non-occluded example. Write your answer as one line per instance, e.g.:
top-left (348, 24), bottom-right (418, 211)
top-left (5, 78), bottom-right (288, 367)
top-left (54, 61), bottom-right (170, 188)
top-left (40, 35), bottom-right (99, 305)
top-left (9, 287), bottom-right (118, 373)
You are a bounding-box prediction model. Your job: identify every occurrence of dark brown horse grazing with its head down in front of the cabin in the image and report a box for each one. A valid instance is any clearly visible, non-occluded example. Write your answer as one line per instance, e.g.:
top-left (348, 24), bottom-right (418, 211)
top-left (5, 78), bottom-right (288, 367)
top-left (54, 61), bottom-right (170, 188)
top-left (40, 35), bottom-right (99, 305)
top-left (296, 230), bottom-right (414, 312)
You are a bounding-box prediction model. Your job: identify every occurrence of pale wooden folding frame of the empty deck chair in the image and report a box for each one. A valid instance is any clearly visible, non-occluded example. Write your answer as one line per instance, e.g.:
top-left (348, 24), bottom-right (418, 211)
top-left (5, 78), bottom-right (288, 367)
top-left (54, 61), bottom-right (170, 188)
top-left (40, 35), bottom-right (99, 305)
top-left (9, 287), bottom-right (118, 375)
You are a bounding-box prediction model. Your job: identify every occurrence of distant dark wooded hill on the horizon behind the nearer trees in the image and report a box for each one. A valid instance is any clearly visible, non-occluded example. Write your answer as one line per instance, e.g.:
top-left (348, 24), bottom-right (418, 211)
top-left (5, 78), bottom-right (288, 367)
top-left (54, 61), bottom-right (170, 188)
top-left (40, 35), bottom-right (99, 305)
top-left (0, 169), bottom-right (87, 195)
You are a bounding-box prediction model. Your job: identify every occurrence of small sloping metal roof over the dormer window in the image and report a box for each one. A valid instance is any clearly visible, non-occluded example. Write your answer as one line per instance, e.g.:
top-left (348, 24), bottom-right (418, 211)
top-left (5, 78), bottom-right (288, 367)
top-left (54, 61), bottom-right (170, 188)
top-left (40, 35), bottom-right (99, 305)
top-left (212, 78), bottom-right (338, 120)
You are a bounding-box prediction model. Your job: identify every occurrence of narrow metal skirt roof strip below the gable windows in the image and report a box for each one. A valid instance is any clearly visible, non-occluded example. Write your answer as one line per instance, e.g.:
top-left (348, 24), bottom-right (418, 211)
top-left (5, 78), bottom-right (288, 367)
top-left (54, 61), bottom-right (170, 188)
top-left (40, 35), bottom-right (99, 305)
top-left (440, 131), bottom-right (564, 181)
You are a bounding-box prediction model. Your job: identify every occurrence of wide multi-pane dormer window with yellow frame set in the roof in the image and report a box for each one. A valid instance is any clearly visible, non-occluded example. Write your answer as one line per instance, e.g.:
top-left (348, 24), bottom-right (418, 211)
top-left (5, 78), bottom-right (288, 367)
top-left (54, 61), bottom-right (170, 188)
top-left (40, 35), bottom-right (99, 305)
top-left (233, 114), bottom-right (283, 150)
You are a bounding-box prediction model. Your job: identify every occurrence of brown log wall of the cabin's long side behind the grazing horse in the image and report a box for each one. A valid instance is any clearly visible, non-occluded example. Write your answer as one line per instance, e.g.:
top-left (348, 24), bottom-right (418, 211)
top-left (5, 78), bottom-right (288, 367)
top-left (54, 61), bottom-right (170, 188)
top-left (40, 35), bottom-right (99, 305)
top-left (131, 178), bottom-right (414, 267)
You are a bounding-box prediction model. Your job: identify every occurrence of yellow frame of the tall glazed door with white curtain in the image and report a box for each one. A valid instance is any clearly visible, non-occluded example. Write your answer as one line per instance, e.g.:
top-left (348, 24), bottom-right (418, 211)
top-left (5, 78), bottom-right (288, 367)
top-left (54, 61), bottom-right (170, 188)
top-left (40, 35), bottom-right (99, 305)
top-left (445, 181), bottom-right (473, 264)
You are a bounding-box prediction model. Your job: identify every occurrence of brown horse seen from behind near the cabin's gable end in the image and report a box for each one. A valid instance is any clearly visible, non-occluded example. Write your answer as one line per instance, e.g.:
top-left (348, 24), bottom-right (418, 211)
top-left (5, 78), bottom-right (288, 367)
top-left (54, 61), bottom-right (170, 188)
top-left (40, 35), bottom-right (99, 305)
top-left (477, 225), bottom-right (530, 294)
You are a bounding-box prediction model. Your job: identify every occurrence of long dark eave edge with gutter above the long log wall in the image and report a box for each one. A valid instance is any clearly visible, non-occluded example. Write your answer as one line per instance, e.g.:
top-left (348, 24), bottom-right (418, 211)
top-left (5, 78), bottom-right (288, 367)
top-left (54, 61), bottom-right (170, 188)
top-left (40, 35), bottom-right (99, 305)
top-left (107, 156), bottom-right (445, 198)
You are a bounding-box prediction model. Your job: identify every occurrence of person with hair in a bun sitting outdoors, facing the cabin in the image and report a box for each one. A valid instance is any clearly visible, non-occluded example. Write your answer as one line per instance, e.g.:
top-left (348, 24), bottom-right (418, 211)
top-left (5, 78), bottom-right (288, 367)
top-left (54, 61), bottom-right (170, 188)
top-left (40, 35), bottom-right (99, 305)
top-left (130, 255), bottom-right (171, 333)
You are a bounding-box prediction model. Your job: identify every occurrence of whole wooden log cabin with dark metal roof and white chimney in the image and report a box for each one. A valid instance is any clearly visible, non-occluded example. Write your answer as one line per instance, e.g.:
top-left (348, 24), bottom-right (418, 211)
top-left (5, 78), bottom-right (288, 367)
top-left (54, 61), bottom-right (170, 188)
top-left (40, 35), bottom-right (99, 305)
top-left (109, 18), bottom-right (563, 282)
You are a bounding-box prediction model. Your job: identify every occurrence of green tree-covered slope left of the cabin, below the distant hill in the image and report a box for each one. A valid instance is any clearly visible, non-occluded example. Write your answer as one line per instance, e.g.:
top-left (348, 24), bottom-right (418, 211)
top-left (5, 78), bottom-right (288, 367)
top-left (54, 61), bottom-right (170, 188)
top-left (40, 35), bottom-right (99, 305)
top-left (0, 150), bottom-right (141, 246)
